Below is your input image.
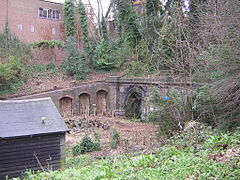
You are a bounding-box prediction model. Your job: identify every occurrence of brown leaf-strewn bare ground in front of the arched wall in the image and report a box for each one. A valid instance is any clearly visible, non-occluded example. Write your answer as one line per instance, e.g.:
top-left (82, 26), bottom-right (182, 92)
top-left (66, 117), bottom-right (159, 158)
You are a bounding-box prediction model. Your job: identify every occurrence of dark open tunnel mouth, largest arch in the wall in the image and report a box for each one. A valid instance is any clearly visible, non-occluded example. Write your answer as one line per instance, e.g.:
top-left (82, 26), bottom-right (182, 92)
top-left (125, 91), bottom-right (143, 119)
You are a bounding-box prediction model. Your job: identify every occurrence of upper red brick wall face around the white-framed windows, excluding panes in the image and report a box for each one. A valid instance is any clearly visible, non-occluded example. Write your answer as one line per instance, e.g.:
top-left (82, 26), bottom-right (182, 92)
top-left (8, 0), bottom-right (64, 42)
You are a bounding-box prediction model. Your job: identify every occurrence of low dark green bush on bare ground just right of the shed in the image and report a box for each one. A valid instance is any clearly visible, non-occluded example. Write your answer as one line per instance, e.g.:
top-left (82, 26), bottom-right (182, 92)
top-left (72, 136), bottom-right (101, 156)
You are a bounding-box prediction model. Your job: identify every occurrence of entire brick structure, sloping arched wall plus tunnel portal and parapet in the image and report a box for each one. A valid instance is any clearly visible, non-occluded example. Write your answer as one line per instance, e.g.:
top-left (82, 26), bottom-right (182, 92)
top-left (10, 76), bottom-right (197, 117)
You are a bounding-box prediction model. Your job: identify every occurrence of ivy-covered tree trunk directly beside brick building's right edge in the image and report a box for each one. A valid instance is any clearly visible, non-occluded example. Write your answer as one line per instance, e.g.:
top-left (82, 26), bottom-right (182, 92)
top-left (64, 0), bottom-right (75, 37)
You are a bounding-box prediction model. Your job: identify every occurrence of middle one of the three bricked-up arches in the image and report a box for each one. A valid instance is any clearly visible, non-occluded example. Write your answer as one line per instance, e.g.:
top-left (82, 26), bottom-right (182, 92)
top-left (79, 93), bottom-right (90, 116)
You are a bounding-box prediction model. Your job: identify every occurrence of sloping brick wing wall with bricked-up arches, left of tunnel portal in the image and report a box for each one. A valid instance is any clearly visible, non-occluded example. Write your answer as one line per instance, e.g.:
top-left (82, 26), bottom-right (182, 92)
top-left (14, 82), bottom-right (110, 116)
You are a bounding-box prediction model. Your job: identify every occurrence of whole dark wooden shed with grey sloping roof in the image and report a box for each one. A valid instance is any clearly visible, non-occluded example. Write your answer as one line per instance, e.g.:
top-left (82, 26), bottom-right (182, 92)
top-left (0, 98), bottom-right (68, 180)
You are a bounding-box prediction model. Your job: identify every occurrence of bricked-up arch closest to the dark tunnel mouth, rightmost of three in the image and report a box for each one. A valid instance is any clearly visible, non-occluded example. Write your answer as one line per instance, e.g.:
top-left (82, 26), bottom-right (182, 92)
top-left (97, 90), bottom-right (108, 114)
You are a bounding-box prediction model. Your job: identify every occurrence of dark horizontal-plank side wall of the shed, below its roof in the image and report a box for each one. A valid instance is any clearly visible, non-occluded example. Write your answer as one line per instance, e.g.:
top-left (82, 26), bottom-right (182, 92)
top-left (0, 134), bottom-right (61, 180)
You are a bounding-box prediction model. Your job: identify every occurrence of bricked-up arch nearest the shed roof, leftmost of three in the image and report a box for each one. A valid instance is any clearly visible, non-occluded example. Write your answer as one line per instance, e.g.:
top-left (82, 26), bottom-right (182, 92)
top-left (59, 97), bottom-right (72, 117)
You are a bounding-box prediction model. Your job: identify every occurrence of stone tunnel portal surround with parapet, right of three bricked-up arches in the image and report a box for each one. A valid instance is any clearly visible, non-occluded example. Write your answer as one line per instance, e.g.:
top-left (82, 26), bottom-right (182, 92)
top-left (106, 77), bottom-right (196, 118)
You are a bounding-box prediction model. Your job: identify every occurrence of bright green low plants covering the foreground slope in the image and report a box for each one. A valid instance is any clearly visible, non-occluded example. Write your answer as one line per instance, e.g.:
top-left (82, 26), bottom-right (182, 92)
top-left (15, 125), bottom-right (240, 180)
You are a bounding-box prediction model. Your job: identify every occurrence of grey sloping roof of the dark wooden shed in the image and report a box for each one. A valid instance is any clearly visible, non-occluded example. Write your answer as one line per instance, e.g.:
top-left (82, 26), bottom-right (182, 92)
top-left (0, 98), bottom-right (68, 138)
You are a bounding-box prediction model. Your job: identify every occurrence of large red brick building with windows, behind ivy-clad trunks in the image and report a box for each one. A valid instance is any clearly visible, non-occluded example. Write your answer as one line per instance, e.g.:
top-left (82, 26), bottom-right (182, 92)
top-left (0, 0), bottom-right (94, 62)
